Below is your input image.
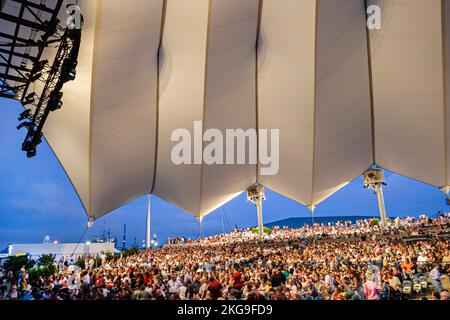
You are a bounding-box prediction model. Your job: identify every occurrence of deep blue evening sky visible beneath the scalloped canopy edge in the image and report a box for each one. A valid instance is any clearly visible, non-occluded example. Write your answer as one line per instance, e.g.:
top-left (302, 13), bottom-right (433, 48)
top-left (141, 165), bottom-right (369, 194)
top-left (0, 98), bottom-right (447, 249)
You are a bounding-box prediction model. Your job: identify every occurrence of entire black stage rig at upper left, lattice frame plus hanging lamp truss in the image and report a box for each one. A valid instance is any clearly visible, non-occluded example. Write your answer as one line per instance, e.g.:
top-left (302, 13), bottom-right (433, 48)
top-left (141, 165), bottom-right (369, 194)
top-left (0, 0), bottom-right (84, 158)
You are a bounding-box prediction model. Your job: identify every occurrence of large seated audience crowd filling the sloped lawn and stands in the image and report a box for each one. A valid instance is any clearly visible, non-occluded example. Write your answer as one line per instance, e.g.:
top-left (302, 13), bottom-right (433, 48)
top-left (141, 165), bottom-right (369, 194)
top-left (0, 216), bottom-right (450, 301)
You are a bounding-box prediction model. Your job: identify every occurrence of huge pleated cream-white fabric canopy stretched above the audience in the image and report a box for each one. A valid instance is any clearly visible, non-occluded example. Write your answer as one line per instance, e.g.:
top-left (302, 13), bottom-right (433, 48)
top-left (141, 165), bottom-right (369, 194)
top-left (1, 0), bottom-right (450, 218)
